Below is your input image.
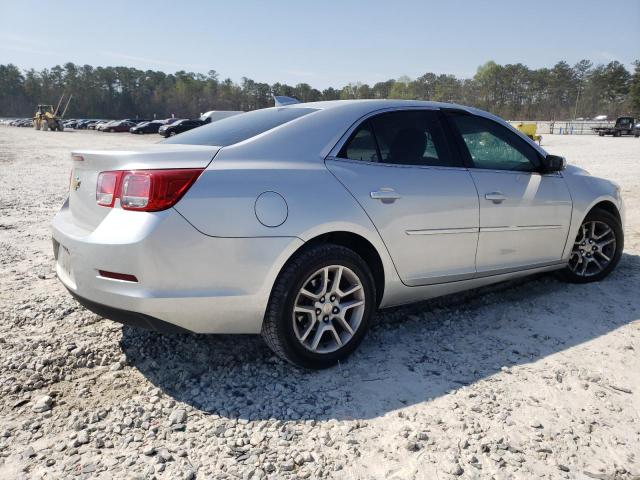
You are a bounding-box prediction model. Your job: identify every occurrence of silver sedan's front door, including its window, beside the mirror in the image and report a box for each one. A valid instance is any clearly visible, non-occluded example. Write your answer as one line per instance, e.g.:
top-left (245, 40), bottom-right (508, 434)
top-left (448, 113), bottom-right (572, 273)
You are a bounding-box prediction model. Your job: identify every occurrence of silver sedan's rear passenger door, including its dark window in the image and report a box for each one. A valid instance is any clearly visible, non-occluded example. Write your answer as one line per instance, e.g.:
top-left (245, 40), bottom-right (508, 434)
top-left (326, 109), bottom-right (479, 285)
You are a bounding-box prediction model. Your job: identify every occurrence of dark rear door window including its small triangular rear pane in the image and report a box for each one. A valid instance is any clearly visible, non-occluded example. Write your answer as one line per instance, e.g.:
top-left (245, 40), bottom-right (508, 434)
top-left (338, 110), bottom-right (459, 167)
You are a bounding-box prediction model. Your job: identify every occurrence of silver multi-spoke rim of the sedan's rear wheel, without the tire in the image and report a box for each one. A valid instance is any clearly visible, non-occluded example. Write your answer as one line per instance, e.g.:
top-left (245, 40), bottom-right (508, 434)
top-left (292, 265), bottom-right (366, 354)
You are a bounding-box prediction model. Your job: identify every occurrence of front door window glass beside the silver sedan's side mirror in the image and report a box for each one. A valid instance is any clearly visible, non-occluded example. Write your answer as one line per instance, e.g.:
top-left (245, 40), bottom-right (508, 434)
top-left (450, 115), bottom-right (539, 172)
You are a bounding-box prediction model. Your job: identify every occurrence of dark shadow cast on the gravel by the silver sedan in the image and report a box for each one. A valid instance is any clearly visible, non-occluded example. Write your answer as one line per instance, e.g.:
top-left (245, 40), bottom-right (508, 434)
top-left (121, 254), bottom-right (640, 420)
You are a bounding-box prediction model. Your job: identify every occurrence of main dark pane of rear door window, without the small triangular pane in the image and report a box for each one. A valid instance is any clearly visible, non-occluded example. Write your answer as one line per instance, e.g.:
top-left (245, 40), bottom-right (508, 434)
top-left (371, 110), bottom-right (457, 167)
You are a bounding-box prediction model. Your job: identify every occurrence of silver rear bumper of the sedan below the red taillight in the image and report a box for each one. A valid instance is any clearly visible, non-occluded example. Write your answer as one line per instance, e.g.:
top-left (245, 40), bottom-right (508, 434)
top-left (52, 204), bottom-right (303, 333)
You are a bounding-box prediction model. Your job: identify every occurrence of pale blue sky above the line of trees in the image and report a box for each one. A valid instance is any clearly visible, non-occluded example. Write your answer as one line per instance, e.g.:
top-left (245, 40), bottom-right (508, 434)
top-left (0, 0), bottom-right (640, 88)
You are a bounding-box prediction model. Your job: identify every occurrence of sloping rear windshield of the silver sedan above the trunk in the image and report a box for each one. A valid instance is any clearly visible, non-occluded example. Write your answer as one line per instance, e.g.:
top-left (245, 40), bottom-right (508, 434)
top-left (162, 108), bottom-right (316, 147)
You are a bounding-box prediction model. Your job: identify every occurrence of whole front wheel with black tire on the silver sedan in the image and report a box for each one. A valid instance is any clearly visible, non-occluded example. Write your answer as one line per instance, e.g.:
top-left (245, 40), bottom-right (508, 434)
top-left (560, 208), bottom-right (624, 283)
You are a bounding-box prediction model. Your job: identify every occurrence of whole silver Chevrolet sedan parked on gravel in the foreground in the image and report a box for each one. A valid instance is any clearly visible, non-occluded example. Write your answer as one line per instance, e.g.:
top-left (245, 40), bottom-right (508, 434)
top-left (53, 100), bottom-right (624, 368)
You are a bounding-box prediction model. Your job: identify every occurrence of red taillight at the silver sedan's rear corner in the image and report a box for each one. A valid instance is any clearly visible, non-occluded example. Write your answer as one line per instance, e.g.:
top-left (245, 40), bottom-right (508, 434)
top-left (96, 168), bottom-right (204, 212)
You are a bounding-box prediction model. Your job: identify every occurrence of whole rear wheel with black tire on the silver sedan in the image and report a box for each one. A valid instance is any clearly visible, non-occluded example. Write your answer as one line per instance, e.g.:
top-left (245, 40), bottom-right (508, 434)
top-left (262, 244), bottom-right (376, 369)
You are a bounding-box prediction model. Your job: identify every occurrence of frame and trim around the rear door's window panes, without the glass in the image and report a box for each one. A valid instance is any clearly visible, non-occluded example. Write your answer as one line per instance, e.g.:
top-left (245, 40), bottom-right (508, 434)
top-left (325, 106), bottom-right (467, 170)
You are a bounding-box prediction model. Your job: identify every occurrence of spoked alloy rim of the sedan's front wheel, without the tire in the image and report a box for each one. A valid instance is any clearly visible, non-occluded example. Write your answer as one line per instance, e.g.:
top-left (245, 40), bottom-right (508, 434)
top-left (569, 220), bottom-right (616, 277)
